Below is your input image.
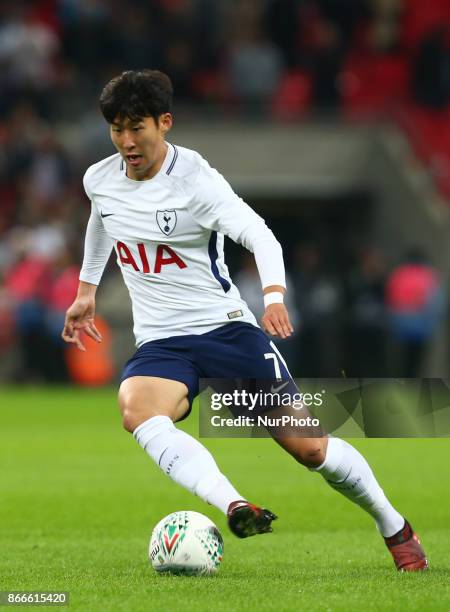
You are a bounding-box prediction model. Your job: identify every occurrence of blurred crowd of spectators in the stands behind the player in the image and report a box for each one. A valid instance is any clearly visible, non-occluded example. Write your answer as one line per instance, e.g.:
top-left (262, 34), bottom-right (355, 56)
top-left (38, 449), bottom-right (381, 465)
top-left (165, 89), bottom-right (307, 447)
top-left (0, 0), bottom-right (450, 380)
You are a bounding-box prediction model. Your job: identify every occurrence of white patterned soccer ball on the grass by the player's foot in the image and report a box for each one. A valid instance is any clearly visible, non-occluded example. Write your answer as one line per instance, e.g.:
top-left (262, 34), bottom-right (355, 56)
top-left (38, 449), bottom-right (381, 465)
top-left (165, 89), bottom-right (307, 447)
top-left (148, 510), bottom-right (223, 576)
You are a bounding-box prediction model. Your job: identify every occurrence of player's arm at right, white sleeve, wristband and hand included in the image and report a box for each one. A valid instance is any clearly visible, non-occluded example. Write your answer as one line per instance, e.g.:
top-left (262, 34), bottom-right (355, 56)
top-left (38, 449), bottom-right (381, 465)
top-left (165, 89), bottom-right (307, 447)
top-left (191, 161), bottom-right (294, 338)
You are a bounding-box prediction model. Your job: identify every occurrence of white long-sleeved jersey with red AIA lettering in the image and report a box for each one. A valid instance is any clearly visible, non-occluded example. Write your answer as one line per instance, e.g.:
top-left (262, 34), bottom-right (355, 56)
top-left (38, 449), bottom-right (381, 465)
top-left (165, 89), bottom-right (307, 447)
top-left (80, 144), bottom-right (285, 346)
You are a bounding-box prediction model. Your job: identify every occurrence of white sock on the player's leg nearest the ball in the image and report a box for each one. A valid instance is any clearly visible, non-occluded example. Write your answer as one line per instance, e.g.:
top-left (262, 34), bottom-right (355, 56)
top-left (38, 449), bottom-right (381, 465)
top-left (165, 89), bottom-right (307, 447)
top-left (133, 416), bottom-right (244, 514)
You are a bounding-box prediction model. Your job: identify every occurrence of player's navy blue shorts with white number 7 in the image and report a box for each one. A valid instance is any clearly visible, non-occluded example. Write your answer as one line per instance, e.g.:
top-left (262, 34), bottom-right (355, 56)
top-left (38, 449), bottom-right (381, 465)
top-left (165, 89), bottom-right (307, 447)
top-left (121, 323), bottom-right (298, 416)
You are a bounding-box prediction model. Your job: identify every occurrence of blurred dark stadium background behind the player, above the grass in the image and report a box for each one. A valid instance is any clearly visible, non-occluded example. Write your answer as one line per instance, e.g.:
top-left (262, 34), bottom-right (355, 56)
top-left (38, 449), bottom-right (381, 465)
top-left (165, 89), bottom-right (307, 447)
top-left (0, 0), bottom-right (450, 384)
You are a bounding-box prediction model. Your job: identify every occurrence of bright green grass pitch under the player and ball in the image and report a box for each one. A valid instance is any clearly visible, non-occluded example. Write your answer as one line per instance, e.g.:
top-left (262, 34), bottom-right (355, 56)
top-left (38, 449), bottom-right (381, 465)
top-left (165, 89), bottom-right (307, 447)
top-left (0, 388), bottom-right (450, 612)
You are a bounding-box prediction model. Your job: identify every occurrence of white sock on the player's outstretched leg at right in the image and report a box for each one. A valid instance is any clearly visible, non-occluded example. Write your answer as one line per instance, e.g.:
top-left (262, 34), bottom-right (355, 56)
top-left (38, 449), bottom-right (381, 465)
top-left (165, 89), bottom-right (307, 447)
top-left (311, 437), bottom-right (405, 538)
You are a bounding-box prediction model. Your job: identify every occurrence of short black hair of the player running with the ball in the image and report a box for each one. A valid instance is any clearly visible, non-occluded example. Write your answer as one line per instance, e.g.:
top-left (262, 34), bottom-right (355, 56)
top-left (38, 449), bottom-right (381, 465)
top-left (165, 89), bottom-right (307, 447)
top-left (100, 69), bottom-right (173, 123)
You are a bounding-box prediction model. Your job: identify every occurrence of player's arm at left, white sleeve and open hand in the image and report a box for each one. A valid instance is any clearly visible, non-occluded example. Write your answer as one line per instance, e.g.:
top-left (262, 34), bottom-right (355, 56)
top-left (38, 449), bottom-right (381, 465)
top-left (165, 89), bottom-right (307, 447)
top-left (61, 166), bottom-right (112, 351)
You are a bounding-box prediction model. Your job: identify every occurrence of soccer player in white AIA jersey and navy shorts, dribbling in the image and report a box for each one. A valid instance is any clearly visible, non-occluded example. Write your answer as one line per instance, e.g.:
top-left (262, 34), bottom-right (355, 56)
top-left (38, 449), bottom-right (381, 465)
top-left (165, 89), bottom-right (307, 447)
top-left (62, 70), bottom-right (427, 571)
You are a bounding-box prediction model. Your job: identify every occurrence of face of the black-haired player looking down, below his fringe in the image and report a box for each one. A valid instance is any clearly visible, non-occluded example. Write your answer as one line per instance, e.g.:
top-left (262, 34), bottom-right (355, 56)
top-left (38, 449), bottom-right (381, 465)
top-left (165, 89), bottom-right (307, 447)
top-left (111, 113), bottom-right (172, 181)
